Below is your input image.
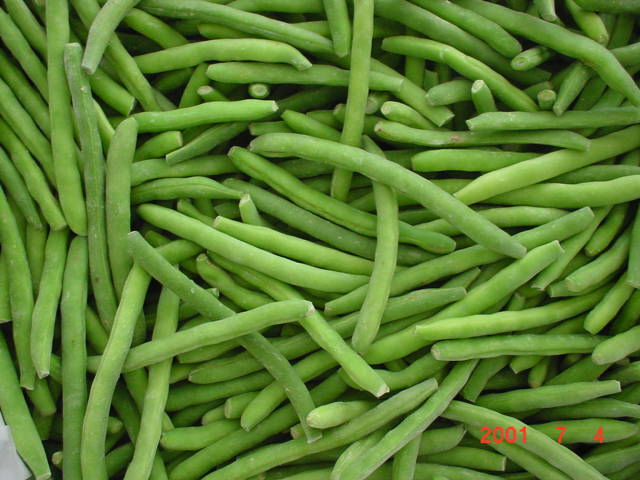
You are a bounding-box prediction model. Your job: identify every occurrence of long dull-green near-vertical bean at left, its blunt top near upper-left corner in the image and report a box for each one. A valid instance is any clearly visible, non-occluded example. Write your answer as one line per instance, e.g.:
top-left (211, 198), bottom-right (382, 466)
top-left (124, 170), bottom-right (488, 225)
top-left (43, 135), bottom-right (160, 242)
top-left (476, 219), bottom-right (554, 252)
top-left (64, 44), bottom-right (116, 326)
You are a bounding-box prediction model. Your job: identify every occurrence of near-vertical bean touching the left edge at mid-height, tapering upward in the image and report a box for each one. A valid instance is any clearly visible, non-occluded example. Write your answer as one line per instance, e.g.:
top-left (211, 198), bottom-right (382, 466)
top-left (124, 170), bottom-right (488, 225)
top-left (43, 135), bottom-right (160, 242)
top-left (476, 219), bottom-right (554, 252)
top-left (0, 186), bottom-right (36, 389)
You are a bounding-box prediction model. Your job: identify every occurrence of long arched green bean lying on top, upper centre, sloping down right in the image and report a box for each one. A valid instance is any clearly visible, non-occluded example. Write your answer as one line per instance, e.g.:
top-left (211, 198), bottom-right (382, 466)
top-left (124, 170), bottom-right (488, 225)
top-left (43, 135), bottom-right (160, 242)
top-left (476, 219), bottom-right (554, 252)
top-left (251, 134), bottom-right (524, 257)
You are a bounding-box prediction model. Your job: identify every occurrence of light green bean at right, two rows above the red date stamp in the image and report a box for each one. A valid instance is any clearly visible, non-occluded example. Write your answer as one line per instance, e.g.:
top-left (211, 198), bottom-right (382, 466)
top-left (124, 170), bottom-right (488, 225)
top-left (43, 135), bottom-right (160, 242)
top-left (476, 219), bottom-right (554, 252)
top-left (415, 289), bottom-right (605, 341)
